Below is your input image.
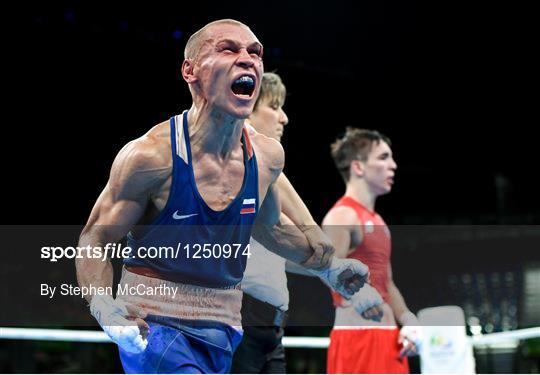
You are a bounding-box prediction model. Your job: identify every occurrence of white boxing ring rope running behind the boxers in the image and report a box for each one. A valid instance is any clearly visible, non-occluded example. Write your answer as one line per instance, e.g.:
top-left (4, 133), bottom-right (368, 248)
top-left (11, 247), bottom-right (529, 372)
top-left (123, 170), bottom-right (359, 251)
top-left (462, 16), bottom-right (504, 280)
top-left (0, 327), bottom-right (540, 349)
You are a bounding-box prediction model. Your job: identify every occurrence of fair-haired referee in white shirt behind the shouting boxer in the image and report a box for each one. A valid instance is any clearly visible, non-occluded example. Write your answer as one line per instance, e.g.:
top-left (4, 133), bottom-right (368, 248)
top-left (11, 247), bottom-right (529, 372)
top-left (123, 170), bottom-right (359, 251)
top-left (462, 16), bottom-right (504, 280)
top-left (232, 73), bottom-right (384, 373)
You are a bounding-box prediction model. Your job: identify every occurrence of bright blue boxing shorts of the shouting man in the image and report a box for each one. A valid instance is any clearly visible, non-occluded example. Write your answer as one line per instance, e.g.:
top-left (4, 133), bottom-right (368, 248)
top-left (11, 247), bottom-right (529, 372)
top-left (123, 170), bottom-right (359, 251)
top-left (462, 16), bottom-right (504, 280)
top-left (118, 315), bottom-right (242, 374)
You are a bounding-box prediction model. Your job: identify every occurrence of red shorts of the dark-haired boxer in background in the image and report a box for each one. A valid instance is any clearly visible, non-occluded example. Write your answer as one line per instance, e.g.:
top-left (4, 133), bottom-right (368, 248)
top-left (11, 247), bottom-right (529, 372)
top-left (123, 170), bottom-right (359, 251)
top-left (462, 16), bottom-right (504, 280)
top-left (327, 328), bottom-right (409, 374)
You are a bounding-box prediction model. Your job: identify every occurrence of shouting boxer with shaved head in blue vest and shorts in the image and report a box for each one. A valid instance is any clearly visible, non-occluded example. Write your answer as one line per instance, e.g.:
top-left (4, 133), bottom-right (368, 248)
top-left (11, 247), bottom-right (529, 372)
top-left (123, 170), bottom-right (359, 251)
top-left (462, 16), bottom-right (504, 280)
top-left (76, 20), bottom-right (368, 373)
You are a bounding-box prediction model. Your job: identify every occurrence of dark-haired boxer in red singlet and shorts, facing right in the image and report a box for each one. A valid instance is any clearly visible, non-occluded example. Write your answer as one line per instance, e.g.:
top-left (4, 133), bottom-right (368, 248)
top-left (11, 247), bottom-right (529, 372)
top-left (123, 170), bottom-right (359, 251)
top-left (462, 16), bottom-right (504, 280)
top-left (323, 128), bottom-right (420, 373)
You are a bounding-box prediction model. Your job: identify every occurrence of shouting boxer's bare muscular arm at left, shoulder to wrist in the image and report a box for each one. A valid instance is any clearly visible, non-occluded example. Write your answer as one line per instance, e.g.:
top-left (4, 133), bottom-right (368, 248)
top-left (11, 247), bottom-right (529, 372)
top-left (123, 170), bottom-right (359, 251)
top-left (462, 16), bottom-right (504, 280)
top-left (75, 139), bottom-right (168, 302)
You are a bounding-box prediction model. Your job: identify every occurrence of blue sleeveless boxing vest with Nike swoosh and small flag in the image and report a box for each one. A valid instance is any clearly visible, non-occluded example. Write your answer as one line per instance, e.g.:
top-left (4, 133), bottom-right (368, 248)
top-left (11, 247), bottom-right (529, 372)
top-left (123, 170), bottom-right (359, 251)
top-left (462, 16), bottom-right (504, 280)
top-left (124, 111), bottom-right (259, 288)
